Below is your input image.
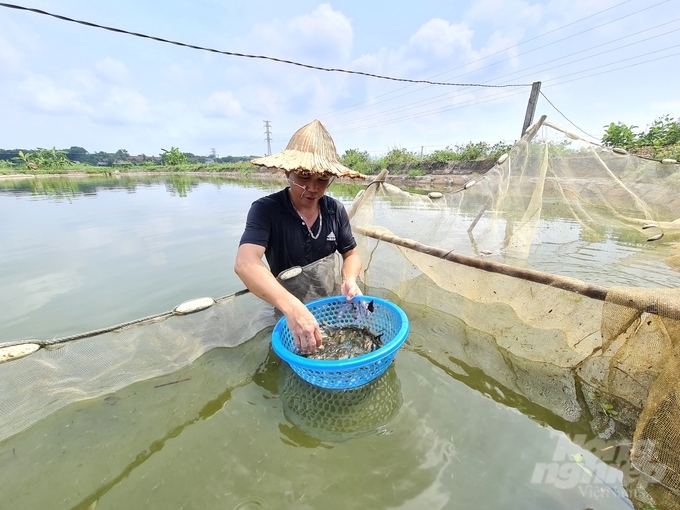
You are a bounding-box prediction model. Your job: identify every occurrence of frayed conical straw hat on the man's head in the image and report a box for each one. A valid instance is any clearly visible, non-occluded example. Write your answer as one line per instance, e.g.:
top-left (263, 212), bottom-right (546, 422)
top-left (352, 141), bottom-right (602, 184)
top-left (251, 120), bottom-right (366, 179)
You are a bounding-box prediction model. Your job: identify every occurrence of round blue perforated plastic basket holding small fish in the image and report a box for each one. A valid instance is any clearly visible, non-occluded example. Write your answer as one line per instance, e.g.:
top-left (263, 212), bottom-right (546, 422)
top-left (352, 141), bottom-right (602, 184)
top-left (272, 296), bottom-right (409, 389)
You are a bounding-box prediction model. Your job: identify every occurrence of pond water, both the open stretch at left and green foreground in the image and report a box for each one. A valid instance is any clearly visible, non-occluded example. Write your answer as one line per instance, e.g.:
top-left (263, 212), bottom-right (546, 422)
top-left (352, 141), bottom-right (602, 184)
top-left (0, 177), bottom-right (648, 510)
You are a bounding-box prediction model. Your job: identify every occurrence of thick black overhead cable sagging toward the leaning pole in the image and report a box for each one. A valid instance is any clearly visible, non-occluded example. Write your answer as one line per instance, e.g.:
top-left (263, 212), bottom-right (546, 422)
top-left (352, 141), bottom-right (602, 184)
top-left (0, 3), bottom-right (532, 88)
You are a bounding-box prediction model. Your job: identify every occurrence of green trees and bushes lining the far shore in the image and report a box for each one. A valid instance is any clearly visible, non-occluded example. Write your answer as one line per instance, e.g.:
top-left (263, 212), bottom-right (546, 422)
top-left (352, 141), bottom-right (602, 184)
top-left (0, 115), bottom-right (680, 177)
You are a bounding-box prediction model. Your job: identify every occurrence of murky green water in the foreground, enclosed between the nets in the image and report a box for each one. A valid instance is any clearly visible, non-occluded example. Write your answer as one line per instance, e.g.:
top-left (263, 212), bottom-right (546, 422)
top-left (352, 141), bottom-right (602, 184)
top-left (0, 322), bottom-right (627, 510)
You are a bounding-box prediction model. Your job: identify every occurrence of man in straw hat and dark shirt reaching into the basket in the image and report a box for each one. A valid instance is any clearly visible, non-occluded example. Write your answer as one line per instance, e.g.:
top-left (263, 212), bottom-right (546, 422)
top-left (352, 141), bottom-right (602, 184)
top-left (234, 120), bottom-right (365, 352)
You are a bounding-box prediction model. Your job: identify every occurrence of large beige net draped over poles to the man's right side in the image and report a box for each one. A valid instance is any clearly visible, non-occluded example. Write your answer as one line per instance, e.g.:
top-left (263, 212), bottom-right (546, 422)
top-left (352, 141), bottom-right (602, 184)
top-left (351, 118), bottom-right (680, 508)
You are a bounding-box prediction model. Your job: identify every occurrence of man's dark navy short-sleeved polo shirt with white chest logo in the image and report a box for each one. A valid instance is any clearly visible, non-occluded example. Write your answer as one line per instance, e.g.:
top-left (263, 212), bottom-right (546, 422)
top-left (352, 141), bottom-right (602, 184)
top-left (239, 188), bottom-right (357, 276)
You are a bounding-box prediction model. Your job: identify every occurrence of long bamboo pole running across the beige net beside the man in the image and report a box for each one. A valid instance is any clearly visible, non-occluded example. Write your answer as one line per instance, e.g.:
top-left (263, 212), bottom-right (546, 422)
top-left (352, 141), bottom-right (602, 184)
top-left (353, 227), bottom-right (609, 301)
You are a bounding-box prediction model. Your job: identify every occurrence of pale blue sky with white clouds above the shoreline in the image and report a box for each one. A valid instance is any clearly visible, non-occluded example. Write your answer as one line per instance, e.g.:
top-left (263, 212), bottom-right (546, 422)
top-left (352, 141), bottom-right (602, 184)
top-left (0, 0), bottom-right (680, 156)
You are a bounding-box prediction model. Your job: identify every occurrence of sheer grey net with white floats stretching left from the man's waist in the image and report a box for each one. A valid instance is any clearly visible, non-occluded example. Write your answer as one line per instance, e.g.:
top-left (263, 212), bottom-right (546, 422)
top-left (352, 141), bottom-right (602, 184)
top-left (0, 256), bottom-right (336, 441)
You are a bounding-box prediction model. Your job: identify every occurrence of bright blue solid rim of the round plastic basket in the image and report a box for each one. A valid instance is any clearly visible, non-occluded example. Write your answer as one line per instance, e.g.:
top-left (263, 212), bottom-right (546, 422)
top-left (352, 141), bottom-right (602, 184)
top-left (272, 296), bottom-right (410, 372)
